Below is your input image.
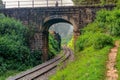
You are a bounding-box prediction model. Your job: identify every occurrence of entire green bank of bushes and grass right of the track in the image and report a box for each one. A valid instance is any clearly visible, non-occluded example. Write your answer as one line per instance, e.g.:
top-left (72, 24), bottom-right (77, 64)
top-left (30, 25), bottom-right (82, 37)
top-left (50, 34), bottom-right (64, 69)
top-left (51, 4), bottom-right (120, 80)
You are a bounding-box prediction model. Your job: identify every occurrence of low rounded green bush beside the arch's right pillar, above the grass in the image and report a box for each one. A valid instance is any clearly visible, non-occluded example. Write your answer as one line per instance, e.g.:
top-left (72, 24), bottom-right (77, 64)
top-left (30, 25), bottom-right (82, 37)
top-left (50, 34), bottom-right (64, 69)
top-left (76, 32), bottom-right (113, 51)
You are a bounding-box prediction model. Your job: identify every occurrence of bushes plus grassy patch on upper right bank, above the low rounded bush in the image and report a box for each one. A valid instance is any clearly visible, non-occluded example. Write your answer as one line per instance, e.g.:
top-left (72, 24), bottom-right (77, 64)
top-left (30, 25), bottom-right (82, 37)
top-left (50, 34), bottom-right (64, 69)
top-left (82, 9), bottom-right (120, 37)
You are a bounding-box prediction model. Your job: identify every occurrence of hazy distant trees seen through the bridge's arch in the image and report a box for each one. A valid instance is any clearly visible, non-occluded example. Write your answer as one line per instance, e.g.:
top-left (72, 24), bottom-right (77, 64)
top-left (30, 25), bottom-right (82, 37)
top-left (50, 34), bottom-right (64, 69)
top-left (50, 23), bottom-right (73, 45)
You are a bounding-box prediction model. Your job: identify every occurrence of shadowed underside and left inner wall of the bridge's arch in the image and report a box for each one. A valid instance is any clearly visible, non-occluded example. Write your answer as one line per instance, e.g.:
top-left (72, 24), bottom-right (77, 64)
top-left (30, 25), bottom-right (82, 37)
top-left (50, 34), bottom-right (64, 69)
top-left (42, 18), bottom-right (76, 59)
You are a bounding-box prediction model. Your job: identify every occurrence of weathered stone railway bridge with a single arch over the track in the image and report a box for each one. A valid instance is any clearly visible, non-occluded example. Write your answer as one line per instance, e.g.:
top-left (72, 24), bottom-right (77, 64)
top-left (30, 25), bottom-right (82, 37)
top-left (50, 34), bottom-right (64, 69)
top-left (0, 5), bottom-right (114, 61)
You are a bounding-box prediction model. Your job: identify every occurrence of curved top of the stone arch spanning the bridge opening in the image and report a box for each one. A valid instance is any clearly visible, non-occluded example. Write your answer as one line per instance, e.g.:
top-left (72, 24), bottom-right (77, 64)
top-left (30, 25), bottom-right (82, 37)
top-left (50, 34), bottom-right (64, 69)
top-left (42, 15), bottom-right (77, 31)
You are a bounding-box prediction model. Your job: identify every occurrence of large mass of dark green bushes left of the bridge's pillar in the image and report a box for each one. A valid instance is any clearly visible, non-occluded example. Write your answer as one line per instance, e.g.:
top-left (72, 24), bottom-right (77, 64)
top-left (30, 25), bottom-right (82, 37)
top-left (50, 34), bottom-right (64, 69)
top-left (0, 14), bottom-right (30, 74)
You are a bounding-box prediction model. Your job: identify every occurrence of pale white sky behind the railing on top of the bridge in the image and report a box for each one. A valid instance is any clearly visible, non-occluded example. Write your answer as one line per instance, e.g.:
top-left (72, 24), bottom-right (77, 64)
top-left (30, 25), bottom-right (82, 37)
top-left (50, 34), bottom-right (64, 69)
top-left (3, 0), bottom-right (73, 8)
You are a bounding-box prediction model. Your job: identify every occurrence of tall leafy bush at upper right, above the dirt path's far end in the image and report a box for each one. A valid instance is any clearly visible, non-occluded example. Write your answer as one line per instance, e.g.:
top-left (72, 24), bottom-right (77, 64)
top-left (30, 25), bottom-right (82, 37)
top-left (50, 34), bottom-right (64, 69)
top-left (96, 9), bottom-right (120, 36)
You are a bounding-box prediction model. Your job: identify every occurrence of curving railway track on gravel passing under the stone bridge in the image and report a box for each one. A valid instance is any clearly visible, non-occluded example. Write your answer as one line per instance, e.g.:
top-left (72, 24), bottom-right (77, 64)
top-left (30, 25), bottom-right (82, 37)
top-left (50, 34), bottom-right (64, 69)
top-left (7, 47), bottom-right (72, 80)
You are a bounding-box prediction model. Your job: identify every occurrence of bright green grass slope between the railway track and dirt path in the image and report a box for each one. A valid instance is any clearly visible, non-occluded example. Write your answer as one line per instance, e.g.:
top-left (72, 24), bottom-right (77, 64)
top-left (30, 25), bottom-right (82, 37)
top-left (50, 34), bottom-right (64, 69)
top-left (50, 46), bottom-right (111, 80)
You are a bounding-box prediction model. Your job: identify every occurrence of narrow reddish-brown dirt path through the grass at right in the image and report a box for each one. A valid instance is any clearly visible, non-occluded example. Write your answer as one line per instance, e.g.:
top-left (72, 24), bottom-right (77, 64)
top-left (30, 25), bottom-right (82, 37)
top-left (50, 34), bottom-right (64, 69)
top-left (106, 41), bottom-right (119, 80)
